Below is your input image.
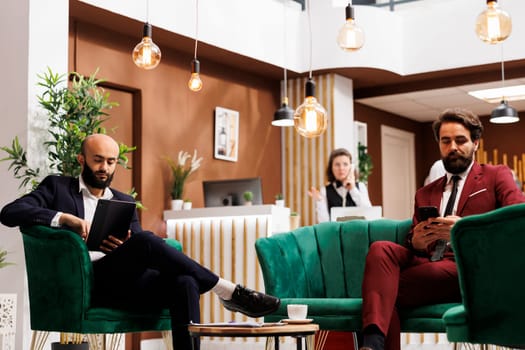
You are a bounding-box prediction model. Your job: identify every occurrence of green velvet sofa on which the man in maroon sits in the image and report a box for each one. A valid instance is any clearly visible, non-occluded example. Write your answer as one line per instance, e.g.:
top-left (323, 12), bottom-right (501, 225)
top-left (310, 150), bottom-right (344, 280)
top-left (255, 219), bottom-right (459, 333)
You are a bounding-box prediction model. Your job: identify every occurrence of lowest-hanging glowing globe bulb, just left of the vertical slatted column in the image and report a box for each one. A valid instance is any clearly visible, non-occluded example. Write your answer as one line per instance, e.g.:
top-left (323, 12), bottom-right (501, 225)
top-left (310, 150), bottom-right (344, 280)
top-left (294, 79), bottom-right (328, 138)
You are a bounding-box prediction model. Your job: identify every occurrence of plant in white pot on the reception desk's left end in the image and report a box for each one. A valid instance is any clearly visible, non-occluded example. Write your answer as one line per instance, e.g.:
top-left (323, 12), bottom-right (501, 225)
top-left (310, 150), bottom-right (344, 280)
top-left (164, 150), bottom-right (202, 210)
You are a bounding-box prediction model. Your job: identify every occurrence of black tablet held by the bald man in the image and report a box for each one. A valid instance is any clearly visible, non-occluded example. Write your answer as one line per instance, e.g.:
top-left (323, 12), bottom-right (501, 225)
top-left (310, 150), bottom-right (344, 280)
top-left (86, 199), bottom-right (136, 250)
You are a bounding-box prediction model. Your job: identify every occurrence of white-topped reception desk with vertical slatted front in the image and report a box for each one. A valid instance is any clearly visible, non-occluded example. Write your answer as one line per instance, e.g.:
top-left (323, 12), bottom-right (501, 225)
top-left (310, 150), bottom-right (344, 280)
top-left (164, 205), bottom-right (290, 322)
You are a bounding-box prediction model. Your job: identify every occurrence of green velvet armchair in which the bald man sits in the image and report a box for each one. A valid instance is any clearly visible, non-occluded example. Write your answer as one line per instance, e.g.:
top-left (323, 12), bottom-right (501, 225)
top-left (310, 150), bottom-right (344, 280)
top-left (21, 226), bottom-right (181, 348)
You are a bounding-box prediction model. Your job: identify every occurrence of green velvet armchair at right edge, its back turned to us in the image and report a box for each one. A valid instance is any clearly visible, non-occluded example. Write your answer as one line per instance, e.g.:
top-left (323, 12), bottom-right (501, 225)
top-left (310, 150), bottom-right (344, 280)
top-left (444, 204), bottom-right (525, 348)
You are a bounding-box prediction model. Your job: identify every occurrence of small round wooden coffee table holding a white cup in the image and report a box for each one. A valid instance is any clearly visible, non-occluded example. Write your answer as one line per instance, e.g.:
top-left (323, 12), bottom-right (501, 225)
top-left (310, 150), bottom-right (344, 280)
top-left (188, 323), bottom-right (319, 350)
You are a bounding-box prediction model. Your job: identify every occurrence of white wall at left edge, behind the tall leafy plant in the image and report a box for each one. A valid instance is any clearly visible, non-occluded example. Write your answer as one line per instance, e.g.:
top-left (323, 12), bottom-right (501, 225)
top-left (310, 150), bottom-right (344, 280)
top-left (0, 0), bottom-right (68, 349)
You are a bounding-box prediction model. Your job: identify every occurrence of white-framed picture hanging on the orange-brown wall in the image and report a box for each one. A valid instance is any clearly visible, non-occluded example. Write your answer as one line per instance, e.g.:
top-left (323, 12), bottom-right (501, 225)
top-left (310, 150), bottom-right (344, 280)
top-left (213, 107), bottom-right (239, 162)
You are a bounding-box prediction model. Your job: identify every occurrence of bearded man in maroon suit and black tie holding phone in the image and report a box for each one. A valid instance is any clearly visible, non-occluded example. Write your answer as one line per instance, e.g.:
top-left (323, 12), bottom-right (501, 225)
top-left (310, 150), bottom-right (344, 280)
top-left (362, 108), bottom-right (525, 350)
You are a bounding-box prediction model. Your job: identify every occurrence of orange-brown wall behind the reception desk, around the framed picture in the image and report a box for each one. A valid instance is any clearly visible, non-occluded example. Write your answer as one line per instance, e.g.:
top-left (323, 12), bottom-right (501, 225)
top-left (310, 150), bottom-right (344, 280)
top-left (70, 22), bottom-right (282, 234)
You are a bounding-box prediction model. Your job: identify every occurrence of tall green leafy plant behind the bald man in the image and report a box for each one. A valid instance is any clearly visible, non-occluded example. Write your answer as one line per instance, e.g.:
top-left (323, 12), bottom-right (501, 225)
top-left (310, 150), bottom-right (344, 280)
top-left (0, 68), bottom-right (136, 196)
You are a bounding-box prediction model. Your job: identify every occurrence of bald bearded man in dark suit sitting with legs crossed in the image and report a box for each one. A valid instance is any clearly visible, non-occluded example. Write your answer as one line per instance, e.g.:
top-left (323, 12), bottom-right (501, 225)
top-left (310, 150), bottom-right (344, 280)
top-left (0, 134), bottom-right (280, 350)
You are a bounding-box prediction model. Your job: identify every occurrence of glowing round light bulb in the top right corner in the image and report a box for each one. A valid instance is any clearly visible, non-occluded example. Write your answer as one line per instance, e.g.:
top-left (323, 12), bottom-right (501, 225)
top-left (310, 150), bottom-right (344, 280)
top-left (476, 0), bottom-right (512, 44)
